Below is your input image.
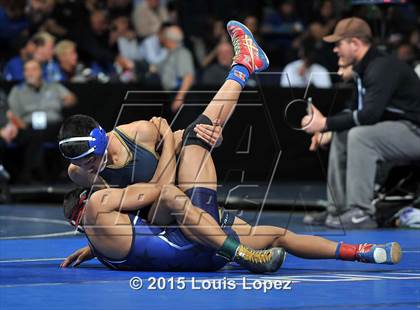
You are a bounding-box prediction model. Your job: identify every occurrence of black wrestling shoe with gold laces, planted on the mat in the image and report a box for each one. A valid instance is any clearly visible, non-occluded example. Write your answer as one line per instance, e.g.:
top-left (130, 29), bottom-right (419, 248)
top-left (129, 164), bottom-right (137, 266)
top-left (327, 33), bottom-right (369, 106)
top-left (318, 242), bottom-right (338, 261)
top-left (233, 245), bottom-right (286, 273)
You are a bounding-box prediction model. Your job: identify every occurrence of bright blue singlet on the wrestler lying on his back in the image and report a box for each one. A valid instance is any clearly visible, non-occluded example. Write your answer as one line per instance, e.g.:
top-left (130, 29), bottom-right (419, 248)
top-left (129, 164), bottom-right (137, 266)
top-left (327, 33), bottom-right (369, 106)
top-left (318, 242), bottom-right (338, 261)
top-left (91, 187), bottom-right (237, 271)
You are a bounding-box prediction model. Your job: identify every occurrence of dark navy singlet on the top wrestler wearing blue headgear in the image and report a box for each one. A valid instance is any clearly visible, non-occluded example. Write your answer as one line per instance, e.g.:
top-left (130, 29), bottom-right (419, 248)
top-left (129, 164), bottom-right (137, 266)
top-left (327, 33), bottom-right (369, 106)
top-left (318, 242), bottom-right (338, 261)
top-left (99, 128), bottom-right (158, 188)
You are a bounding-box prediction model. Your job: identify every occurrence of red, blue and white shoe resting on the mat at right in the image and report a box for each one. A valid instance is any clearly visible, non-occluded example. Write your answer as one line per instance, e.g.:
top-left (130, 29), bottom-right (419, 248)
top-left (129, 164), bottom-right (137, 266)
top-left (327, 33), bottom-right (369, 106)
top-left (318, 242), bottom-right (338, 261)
top-left (356, 242), bottom-right (402, 265)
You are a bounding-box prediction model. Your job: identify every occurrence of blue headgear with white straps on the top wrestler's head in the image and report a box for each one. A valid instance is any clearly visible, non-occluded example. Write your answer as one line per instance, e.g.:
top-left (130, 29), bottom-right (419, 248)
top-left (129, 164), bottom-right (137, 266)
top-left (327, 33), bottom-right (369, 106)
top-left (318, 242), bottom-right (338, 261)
top-left (58, 127), bottom-right (108, 160)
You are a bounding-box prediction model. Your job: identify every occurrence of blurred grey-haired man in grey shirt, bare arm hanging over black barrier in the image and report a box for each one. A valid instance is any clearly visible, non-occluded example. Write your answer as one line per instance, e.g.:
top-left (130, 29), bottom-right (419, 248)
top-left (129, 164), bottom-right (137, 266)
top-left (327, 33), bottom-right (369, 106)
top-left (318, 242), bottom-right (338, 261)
top-left (158, 26), bottom-right (194, 112)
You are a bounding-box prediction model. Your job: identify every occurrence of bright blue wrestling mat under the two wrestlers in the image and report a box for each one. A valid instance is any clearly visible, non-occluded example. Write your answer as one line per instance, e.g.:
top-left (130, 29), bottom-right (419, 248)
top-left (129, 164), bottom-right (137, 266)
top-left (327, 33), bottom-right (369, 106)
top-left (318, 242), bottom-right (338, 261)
top-left (0, 205), bottom-right (420, 310)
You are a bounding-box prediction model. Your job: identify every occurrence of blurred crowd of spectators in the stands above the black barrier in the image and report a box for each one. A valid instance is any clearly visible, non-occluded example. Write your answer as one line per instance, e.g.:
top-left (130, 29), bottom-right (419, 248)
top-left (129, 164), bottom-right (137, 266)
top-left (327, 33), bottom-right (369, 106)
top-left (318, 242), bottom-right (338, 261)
top-left (0, 0), bottom-right (420, 89)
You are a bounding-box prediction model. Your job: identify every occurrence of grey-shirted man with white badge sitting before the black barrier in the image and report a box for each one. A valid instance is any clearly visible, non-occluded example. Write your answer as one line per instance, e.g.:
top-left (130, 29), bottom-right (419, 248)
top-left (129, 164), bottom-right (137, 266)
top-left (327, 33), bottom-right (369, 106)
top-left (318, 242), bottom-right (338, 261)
top-left (8, 60), bottom-right (76, 183)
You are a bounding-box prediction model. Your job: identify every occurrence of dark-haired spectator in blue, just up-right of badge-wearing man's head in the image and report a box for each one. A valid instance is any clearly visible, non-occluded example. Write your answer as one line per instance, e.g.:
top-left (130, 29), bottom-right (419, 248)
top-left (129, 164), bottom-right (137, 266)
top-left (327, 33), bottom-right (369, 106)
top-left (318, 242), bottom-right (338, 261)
top-left (33, 32), bottom-right (61, 82)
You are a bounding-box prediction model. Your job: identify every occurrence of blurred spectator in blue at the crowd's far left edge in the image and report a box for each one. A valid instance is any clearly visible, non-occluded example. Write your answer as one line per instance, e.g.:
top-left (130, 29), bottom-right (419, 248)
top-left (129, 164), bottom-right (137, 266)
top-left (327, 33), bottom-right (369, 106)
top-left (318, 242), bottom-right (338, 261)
top-left (4, 38), bottom-right (35, 82)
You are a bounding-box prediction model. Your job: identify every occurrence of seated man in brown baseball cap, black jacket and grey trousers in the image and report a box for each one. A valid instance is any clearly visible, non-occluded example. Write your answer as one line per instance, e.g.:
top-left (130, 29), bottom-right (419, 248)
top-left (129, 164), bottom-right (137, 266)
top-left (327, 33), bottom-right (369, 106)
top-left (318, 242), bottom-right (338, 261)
top-left (302, 17), bottom-right (420, 229)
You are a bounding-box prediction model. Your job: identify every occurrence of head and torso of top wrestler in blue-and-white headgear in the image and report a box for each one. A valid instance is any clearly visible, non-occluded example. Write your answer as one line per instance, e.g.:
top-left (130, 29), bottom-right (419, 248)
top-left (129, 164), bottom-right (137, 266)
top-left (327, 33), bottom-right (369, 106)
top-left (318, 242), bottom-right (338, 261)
top-left (59, 115), bottom-right (158, 187)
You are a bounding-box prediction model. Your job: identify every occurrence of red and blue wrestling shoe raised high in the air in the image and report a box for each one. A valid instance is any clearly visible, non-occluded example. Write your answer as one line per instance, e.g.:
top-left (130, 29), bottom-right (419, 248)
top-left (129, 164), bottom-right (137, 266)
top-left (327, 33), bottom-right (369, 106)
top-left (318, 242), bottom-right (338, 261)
top-left (227, 20), bottom-right (269, 74)
